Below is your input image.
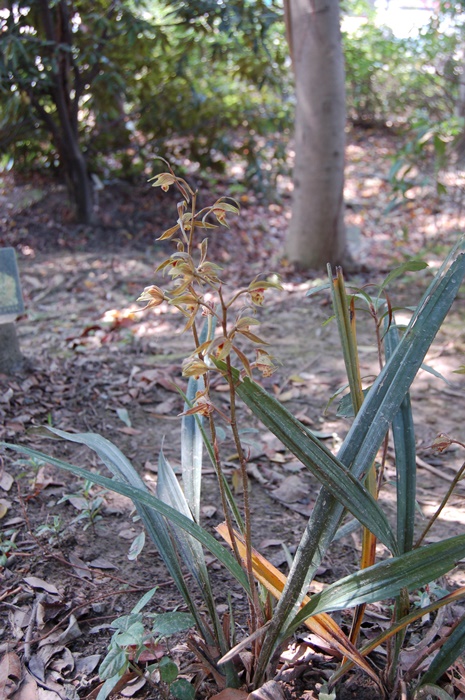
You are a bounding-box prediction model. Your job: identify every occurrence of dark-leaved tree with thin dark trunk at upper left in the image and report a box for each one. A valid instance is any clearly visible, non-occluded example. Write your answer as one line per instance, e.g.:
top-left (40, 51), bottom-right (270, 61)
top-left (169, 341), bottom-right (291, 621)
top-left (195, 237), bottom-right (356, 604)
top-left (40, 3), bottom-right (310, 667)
top-left (0, 0), bottom-right (156, 223)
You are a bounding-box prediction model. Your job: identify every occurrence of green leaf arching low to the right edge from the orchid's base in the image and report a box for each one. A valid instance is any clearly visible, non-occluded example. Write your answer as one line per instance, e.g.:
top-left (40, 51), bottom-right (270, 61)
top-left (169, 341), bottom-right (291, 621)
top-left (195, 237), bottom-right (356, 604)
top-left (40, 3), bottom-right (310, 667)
top-left (286, 535), bottom-right (465, 628)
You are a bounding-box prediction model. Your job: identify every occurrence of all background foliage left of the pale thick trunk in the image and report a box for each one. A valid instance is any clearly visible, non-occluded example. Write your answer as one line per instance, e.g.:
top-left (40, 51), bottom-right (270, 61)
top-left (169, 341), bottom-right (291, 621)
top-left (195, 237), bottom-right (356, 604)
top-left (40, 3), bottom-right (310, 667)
top-left (0, 0), bottom-right (292, 185)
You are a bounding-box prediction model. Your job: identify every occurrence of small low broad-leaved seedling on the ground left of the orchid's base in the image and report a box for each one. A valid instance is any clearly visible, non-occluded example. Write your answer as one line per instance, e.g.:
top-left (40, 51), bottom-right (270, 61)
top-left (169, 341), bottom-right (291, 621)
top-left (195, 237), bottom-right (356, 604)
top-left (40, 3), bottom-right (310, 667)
top-left (97, 588), bottom-right (195, 700)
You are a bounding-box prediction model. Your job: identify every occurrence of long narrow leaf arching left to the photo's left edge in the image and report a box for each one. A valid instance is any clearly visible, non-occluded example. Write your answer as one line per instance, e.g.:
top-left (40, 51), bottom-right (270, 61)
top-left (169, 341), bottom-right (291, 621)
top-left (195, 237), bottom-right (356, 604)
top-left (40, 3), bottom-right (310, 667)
top-left (0, 442), bottom-right (249, 592)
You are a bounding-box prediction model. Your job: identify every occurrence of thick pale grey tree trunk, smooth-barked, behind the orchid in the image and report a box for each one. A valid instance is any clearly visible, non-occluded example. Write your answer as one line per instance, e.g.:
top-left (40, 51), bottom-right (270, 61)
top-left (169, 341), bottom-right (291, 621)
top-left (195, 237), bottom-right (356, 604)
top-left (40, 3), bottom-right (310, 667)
top-left (286, 0), bottom-right (345, 268)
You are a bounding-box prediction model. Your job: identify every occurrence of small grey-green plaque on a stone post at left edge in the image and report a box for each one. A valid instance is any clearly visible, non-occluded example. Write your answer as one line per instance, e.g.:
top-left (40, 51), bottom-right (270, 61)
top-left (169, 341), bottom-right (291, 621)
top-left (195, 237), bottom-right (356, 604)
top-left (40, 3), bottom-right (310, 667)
top-left (0, 248), bottom-right (24, 374)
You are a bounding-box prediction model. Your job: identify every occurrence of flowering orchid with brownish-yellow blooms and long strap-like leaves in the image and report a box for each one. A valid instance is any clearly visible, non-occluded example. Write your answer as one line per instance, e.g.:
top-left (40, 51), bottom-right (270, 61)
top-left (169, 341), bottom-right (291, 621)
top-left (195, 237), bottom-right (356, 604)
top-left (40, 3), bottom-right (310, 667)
top-left (4, 161), bottom-right (465, 700)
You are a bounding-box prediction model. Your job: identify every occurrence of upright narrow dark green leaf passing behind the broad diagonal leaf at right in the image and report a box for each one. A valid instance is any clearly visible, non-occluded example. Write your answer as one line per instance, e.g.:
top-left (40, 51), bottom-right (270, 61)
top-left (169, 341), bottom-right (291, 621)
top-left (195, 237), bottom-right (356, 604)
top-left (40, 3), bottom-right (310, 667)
top-left (384, 323), bottom-right (417, 553)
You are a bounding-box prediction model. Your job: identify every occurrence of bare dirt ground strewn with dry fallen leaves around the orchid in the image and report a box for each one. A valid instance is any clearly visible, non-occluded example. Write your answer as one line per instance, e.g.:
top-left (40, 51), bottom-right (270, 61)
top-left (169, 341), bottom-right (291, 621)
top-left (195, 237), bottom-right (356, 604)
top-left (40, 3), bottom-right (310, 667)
top-left (0, 131), bottom-right (465, 700)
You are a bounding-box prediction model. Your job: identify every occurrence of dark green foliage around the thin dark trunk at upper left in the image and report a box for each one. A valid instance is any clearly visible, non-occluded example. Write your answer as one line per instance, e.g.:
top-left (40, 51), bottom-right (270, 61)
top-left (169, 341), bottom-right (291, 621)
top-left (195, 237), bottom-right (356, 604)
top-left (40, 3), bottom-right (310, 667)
top-left (0, 0), bottom-right (154, 173)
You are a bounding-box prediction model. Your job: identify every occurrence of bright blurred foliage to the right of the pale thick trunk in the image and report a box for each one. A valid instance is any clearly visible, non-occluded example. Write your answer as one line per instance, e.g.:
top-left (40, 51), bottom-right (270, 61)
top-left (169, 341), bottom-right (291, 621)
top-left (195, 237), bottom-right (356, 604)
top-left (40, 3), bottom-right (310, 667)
top-left (344, 1), bottom-right (464, 201)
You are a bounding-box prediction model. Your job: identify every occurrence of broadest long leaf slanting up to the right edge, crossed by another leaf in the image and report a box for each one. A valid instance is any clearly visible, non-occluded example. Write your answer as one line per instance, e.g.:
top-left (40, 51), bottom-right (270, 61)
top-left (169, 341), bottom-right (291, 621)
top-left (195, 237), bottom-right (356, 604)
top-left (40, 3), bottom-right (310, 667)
top-left (252, 249), bottom-right (465, 682)
